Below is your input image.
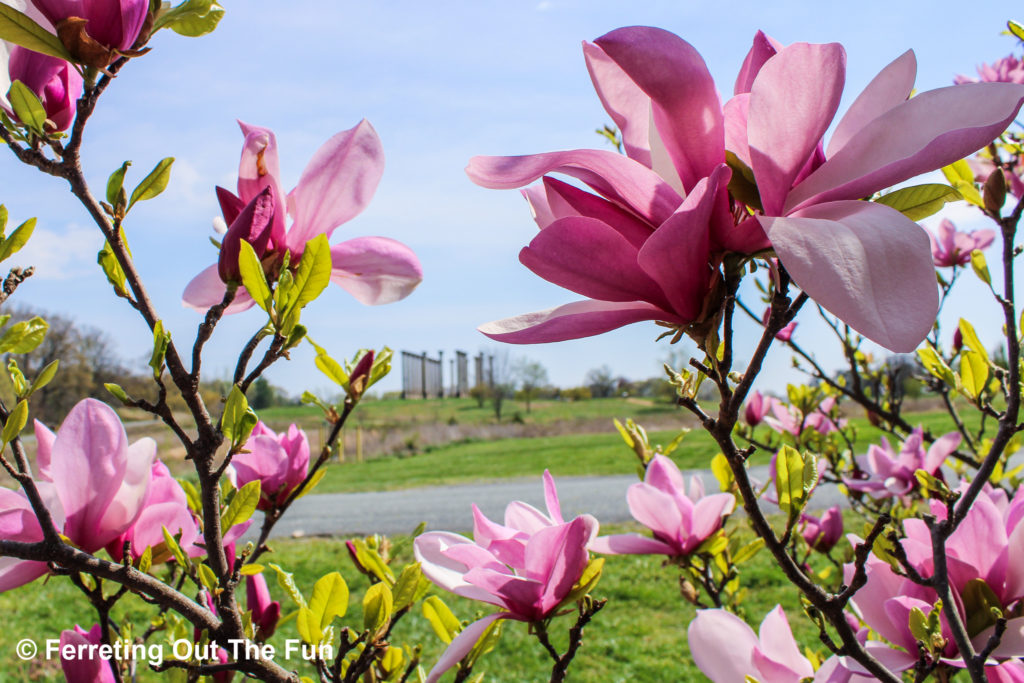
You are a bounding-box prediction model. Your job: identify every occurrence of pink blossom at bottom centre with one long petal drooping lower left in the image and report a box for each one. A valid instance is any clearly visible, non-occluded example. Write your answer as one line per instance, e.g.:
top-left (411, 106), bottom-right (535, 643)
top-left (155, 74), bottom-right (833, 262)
top-left (414, 471), bottom-right (598, 682)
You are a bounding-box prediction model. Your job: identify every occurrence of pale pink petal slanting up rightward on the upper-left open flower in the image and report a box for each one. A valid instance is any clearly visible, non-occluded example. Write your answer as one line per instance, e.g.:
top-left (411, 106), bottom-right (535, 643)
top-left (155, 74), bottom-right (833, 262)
top-left (288, 119), bottom-right (384, 252)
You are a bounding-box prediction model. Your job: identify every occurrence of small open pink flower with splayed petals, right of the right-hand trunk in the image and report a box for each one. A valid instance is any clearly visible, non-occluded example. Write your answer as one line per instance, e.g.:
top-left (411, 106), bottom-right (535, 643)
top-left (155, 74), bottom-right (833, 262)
top-left (843, 427), bottom-right (961, 499)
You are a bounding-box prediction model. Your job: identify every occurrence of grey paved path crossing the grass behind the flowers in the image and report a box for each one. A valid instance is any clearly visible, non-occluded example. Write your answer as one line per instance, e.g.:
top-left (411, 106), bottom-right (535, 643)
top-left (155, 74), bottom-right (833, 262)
top-left (254, 466), bottom-right (841, 537)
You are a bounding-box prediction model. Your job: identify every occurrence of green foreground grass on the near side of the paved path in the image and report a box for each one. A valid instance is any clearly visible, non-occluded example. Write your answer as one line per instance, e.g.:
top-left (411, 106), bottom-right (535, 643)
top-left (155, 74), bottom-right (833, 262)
top-left (0, 517), bottom-right (820, 683)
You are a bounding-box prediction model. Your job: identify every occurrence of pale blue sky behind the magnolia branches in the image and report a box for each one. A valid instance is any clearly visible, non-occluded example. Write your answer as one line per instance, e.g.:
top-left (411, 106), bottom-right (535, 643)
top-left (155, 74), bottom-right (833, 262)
top-left (0, 0), bottom-right (1014, 393)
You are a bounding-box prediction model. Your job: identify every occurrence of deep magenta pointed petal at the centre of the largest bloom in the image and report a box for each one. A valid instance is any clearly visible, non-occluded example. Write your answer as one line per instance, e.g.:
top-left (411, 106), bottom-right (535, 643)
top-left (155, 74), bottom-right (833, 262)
top-left (637, 164), bottom-right (730, 321)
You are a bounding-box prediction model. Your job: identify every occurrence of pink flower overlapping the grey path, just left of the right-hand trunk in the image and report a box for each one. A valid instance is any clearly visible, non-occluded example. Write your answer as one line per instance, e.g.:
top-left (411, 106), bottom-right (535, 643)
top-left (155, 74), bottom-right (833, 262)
top-left (590, 455), bottom-right (736, 556)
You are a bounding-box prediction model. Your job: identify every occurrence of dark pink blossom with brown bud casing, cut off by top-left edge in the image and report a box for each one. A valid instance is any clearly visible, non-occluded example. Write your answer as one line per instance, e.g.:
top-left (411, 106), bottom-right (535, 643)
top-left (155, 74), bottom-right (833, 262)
top-left (32, 0), bottom-right (150, 54)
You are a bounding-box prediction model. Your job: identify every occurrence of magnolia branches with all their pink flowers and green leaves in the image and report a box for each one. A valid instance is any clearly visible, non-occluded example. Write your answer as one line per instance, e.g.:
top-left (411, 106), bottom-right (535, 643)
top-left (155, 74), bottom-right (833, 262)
top-left (0, 0), bottom-right (1024, 683)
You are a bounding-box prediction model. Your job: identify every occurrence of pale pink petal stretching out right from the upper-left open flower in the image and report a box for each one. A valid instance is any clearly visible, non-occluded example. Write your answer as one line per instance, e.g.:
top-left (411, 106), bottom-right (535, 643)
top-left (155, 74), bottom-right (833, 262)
top-left (331, 238), bottom-right (423, 306)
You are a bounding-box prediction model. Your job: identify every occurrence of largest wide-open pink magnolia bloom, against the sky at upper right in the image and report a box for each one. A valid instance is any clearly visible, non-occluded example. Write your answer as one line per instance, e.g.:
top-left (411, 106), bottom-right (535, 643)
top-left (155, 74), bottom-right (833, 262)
top-left (467, 27), bottom-right (1024, 351)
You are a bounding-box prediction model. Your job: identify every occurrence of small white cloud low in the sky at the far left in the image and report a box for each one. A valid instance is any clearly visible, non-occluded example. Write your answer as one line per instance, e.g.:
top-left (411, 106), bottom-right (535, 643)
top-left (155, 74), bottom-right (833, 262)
top-left (11, 223), bottom-right (103, 280)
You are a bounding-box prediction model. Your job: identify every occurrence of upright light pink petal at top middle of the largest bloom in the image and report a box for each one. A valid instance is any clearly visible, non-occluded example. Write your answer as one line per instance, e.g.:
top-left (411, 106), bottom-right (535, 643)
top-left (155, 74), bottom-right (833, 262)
top-left (746, 43), bottom-right (846, 215)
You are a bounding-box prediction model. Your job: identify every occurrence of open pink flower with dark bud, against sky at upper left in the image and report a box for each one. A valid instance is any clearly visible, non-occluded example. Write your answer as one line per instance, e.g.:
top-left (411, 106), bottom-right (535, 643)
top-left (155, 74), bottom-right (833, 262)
top-left (182, 121), bottom-right (423, 313)
